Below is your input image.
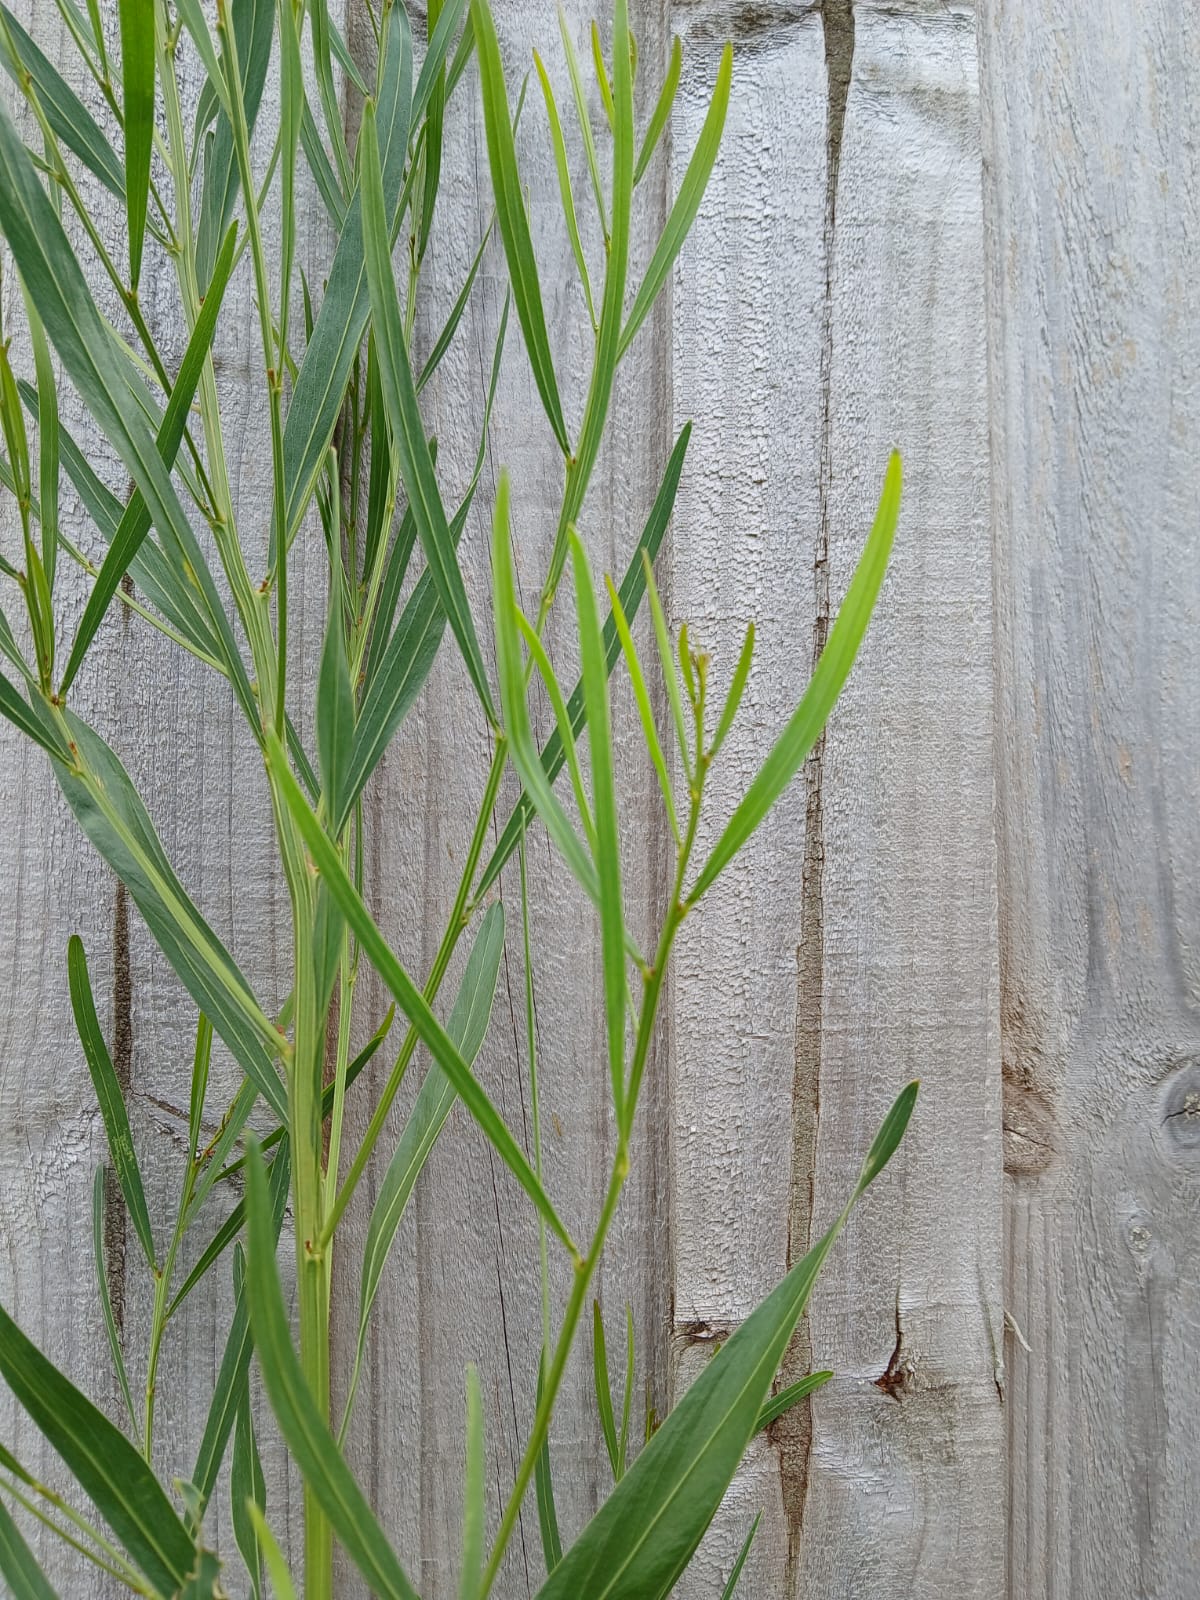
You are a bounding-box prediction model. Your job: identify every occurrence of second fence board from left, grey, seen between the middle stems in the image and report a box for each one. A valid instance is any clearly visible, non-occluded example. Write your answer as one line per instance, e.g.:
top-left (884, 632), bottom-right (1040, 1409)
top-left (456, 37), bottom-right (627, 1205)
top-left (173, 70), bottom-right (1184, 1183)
top-left (334, 0), bottom-right (672, 1600)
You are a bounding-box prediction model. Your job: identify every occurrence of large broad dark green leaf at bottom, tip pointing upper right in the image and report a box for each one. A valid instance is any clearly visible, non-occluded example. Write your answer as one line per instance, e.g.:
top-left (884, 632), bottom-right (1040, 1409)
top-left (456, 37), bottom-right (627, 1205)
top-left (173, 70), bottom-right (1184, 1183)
top-left (538, 1085), bottom-right (915, 1600)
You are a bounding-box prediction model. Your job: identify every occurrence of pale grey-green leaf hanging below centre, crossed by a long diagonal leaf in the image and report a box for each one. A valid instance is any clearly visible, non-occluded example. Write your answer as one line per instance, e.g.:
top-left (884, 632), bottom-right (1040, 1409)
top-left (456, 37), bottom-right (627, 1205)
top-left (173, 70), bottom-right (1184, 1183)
top-left (352, 901), bottom-right (504, 1430)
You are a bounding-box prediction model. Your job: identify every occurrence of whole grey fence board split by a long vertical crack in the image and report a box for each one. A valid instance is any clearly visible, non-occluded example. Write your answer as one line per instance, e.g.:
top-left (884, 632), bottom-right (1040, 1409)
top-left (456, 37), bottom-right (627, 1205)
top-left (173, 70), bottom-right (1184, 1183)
top-left (674, 5), bottom-right (1005, 1597)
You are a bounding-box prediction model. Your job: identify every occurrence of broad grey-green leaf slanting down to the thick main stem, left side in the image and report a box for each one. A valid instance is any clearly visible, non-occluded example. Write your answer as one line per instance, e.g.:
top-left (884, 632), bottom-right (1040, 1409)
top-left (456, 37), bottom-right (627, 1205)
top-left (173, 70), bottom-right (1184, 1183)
top-left (54, 712), bottom-right (286, 1120)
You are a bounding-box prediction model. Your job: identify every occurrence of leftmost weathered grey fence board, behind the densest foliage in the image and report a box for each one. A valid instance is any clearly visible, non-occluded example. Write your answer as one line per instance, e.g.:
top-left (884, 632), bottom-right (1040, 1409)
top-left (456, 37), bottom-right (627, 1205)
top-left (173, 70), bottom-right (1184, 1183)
top-left (0, 5), bottom-right (342, 1594)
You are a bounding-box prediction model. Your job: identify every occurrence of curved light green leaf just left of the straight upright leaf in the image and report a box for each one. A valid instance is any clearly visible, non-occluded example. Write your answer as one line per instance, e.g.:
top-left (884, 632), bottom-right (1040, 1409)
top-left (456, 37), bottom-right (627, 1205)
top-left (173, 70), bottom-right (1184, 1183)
top-left (491, 472), bottom-right (600, 902)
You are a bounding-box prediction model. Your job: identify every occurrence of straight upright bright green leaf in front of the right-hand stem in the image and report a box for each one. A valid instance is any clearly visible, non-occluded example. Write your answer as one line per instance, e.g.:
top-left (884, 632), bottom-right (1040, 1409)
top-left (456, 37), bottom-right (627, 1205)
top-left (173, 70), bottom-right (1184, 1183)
top-left (569, 530), bottom-right (626, 1120)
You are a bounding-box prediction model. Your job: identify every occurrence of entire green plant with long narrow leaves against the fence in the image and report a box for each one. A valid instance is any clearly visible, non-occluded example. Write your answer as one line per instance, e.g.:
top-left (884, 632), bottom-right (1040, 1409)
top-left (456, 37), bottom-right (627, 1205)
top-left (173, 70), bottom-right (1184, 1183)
top-left (0, 0), bottom-right (915, 1600)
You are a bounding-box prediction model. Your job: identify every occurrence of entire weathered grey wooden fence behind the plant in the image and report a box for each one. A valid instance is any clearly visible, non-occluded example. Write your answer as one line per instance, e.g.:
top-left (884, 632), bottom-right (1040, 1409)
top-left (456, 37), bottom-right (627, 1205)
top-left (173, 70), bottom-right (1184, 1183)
top-left (0, 0), bottom-right (1200, 1600)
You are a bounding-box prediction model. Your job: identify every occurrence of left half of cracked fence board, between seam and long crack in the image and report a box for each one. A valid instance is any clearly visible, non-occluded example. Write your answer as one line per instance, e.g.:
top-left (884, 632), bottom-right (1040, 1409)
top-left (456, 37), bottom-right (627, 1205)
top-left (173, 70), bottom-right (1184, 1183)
top-left (670, 6), bottom-right (826, 1597)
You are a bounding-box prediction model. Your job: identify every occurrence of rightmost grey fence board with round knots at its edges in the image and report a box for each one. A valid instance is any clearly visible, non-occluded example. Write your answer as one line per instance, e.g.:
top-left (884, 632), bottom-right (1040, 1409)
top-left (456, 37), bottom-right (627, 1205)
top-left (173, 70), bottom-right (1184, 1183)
top-left (981, 0), bottom-right (1200, 1600)
